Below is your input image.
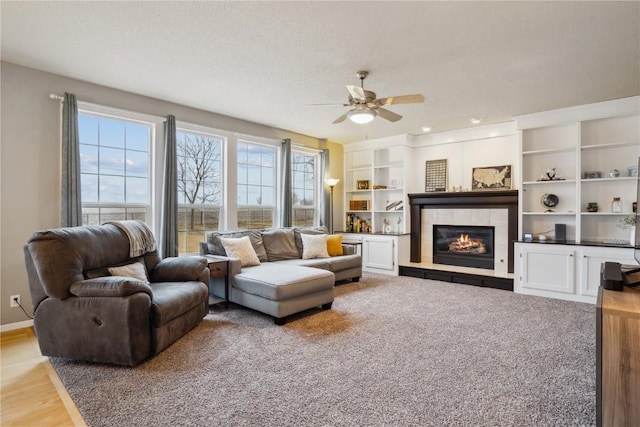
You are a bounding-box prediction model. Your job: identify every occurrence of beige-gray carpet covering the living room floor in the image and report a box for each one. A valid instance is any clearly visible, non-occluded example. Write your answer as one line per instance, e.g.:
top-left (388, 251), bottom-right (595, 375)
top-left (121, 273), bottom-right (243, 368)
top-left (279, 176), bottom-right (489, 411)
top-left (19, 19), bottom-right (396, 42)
top-left (52, 274), bottom-right (595, 426)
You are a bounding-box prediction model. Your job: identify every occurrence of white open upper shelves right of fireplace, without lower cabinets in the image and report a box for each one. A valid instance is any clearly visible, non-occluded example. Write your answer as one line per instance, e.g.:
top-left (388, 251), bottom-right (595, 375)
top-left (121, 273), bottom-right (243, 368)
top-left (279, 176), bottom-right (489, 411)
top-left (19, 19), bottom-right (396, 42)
top-left (516, 96), bottom-right (640, 245)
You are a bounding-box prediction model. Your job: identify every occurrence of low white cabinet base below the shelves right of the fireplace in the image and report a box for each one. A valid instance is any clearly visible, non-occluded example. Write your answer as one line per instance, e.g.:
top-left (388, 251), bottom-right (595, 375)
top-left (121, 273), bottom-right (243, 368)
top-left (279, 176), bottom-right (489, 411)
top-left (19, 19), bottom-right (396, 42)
top-left (513, 242), bottom-right (637, 304)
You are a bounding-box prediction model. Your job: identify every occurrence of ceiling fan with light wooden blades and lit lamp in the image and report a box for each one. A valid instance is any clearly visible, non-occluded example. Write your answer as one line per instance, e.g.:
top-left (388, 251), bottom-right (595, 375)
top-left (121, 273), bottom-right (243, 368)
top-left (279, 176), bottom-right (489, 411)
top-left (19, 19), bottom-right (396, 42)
top-left (310, 71), bottom-right (424, 124)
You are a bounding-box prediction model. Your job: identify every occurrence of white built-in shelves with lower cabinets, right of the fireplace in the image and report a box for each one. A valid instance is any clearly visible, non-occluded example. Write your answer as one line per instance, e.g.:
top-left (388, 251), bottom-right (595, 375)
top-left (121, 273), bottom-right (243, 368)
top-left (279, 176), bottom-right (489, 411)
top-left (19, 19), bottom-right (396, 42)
top-left (514, 96), bottom-right (640, 303)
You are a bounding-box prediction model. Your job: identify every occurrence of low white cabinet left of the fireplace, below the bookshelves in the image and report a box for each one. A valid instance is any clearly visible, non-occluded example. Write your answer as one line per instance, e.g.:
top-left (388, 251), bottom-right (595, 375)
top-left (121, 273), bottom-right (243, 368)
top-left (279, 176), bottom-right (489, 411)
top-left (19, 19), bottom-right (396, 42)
top-left (343, 233), bottom-right (411, 276)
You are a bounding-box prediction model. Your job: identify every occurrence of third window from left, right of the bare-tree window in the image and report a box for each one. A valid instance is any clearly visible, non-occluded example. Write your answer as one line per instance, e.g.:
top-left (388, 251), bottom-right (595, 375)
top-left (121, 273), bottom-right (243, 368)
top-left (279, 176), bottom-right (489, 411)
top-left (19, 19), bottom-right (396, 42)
top-left (237, 141), bottom-right (277, 229)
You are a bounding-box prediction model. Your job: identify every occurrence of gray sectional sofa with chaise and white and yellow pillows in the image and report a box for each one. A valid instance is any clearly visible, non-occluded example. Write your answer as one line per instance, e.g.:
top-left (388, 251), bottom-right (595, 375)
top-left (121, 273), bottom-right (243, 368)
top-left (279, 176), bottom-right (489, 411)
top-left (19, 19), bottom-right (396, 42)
top-left (200, 227), bottom-right (362, 325)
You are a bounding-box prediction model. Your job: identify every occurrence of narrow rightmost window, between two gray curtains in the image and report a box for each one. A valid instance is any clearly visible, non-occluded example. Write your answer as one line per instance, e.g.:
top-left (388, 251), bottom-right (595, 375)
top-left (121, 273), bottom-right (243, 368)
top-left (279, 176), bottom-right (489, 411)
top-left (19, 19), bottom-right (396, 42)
top-left (291, 152), bottom-right (319, 227)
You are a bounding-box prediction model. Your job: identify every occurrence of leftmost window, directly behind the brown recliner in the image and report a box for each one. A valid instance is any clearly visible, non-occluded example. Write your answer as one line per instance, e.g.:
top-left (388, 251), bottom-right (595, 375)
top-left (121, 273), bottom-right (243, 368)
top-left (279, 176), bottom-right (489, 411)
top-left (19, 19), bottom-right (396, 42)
top-left (78, 112), bottom-right (153, 225)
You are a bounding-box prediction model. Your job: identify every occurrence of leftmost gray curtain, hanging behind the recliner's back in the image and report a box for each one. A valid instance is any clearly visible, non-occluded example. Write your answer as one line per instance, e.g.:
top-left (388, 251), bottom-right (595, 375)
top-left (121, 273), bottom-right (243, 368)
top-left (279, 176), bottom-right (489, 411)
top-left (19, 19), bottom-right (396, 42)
top-left (60, 93), bottom-right (82, 227)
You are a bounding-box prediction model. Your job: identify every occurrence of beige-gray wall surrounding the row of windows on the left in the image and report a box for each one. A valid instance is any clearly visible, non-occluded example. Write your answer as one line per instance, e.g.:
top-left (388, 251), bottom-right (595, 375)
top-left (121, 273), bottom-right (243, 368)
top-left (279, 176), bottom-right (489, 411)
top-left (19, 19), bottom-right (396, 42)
top-left (0, 62), bottom-right (343, 329)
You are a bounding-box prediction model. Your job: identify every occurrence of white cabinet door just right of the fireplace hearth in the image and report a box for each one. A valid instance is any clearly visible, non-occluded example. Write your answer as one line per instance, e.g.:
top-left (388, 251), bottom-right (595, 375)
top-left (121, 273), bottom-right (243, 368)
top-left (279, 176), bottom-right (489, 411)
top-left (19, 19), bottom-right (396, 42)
top-left (521, 245), bottom-right (575, 294)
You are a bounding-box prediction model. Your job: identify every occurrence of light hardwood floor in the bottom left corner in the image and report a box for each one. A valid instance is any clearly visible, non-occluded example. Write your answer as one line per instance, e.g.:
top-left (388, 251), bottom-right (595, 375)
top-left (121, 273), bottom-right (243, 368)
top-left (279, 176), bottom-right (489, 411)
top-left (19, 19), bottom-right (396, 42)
top-left (0, 328), bottom-right (86, 427)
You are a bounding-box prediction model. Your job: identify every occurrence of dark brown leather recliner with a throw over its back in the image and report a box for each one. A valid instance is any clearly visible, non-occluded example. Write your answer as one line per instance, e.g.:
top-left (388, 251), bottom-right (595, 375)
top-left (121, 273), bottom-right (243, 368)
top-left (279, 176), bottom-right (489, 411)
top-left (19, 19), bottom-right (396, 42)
top-left (24, 224), bottom-right (209, 366)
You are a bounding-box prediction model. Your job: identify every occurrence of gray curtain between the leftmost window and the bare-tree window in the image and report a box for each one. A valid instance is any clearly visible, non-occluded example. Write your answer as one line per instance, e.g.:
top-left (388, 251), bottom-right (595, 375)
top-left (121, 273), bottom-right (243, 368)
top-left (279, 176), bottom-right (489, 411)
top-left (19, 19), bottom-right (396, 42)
top-left (159, 115), bottom-right (178, 258)
